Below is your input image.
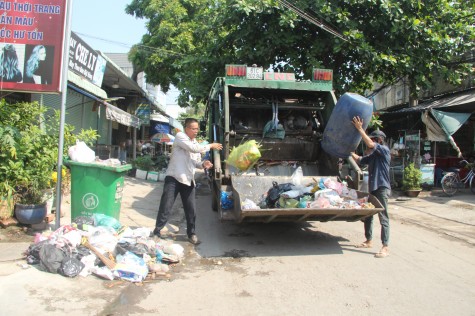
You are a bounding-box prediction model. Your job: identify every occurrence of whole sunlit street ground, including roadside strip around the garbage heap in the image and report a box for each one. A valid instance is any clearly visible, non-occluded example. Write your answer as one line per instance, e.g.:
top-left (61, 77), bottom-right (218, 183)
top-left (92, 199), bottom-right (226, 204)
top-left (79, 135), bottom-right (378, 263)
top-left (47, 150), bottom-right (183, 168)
top-left (0, 174), bottom-right (475, 316)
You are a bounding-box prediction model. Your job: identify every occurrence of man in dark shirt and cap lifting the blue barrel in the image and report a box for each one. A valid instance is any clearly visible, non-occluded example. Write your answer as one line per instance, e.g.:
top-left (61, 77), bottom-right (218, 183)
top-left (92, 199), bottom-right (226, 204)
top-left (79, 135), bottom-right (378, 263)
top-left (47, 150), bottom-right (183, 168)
top-left (351, 116), bottom-right (391, 258)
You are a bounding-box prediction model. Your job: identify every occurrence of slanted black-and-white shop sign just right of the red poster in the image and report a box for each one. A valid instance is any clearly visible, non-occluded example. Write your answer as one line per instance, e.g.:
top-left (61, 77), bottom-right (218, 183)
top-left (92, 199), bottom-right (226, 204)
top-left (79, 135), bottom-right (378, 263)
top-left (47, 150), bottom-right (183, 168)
top-left (68, 32), bottom-right (107, 87)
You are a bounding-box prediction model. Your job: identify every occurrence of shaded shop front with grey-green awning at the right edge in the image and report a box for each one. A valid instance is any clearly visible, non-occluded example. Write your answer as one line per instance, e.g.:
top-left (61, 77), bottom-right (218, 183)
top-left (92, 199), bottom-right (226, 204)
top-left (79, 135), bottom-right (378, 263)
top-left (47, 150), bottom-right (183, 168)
top-left (381, 90), bottom-right (475, 187)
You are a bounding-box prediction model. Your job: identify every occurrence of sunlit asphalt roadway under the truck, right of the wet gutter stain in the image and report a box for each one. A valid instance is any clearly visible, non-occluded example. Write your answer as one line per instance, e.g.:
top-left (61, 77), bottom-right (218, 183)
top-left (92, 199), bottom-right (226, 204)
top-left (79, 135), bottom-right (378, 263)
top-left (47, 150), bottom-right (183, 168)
top-left (102, 177), bottom-right (475, 315)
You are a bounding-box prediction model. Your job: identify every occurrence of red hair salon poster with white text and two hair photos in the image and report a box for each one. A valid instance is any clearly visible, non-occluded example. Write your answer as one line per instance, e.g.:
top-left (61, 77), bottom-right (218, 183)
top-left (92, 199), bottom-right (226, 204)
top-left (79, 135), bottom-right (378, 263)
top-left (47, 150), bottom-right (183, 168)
top-left (0, 0), bottom-right (68, 93)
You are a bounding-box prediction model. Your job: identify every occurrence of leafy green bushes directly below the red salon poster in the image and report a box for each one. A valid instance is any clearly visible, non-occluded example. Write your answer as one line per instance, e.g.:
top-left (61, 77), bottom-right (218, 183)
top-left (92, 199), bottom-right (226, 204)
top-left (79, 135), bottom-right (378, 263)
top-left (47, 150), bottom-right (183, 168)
top-left (0, 100), bottom-right (97, 204)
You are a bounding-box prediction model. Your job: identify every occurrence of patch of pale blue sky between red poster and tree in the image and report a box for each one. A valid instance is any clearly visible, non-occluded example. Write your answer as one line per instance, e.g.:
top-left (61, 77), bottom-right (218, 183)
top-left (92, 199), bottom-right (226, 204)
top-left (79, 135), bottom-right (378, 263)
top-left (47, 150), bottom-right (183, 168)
top-left (71, 0), bottom-right (146, 53)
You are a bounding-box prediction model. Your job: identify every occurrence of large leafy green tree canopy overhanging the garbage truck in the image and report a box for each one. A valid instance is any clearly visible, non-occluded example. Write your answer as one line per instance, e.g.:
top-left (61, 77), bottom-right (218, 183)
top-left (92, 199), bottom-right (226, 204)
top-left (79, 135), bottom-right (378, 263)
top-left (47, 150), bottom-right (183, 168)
top-left (126, 0), bottom-right (475, 106)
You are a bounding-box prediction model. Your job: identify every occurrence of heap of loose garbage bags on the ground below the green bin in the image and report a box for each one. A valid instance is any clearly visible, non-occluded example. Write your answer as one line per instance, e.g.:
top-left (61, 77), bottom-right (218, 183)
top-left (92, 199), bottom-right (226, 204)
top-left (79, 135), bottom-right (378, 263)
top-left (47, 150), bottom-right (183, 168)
top-left (25, 214), bottom-right (184, 282)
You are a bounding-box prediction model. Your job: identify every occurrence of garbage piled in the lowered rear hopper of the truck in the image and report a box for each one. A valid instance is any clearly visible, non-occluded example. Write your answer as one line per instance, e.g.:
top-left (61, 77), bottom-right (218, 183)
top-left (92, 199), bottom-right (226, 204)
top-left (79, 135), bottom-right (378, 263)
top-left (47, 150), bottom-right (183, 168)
top-left (234, 167), bottom-right (375, 210)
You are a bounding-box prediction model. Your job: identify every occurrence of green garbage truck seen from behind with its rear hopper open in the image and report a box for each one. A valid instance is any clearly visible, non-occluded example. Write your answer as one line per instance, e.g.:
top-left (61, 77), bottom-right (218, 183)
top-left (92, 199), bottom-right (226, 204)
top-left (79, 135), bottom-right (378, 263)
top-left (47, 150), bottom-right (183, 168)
top-left (201, 65), bottom-right (382, 223)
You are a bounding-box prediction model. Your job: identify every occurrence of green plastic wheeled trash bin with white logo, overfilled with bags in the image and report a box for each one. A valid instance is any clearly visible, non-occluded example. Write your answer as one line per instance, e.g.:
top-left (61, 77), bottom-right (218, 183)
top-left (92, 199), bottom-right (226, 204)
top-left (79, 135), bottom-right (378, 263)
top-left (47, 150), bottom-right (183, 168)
top-left (65, 161), bottom-right (132, 220)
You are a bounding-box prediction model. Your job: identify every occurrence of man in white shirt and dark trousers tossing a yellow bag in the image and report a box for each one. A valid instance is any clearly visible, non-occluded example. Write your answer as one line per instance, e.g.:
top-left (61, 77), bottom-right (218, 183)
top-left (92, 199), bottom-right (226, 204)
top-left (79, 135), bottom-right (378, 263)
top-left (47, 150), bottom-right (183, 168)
top-left (153, 118), bottom-right (223, 245)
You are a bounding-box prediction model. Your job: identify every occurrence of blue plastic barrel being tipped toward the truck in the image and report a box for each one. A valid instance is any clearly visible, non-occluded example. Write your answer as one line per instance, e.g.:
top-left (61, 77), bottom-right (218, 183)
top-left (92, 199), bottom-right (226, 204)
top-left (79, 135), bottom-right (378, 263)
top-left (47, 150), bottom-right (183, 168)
top-left (322, 93), bottom-right (373, 158)
